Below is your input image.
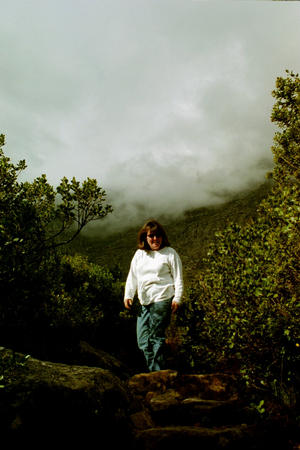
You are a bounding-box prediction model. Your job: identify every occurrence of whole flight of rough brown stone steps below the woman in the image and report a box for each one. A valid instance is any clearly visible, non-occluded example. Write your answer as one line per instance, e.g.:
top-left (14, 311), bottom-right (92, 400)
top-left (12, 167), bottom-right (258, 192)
top-left (128, 370), bottom-right (287, 450)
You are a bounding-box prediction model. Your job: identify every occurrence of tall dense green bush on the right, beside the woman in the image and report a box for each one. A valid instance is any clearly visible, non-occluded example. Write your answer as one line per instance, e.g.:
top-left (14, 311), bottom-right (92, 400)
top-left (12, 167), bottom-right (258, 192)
top-left (181, 72), bottom-right (300, 402)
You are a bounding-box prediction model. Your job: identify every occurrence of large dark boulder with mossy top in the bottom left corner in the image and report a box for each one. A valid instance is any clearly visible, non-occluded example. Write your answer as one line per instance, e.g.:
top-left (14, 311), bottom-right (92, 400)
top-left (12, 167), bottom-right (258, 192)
top-left (0, 349), bottom-right (131, 448)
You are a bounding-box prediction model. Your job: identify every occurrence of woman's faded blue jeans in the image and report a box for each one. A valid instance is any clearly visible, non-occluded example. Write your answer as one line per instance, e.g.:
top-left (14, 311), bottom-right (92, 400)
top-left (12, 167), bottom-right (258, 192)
top-left (136, 298), bottom-right (173, 372)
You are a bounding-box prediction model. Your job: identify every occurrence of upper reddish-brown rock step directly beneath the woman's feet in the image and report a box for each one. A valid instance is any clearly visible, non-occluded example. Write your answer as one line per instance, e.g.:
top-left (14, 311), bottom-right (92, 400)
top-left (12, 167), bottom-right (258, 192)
top-left (129, 370), bottom-right (246, 426)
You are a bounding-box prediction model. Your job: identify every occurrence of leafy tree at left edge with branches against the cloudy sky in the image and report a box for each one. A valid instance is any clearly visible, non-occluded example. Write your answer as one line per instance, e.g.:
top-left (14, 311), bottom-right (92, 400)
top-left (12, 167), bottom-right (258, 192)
top-left (0, 135), bottom-right (112, 265)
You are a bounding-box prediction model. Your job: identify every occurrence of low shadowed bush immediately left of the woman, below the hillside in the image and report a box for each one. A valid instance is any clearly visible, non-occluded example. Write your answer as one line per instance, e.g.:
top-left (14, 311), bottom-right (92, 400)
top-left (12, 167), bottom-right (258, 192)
top-left (47, 255), bottom-right (123, 347)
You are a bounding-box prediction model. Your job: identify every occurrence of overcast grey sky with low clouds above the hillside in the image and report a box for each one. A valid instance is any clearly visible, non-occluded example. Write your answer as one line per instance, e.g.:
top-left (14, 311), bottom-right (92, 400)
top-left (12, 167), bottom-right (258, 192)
top-left (0, 0), bottom-right (300, 232)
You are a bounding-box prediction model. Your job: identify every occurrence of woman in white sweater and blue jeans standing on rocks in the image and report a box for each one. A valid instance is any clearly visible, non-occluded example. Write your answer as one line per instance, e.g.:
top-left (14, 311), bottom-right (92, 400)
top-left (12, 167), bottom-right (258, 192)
top-left (124, 220), bottom-right (183, 372)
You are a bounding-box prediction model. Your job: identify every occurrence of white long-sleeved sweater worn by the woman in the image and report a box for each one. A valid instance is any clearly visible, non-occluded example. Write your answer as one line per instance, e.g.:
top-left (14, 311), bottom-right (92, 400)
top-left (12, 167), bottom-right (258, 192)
top-left (124, 247), bottom-right (183, 305)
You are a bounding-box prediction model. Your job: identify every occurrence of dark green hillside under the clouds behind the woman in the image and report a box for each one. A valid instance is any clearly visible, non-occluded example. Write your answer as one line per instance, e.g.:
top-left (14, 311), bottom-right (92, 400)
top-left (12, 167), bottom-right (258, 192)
top-left (69, 182), bottom-right (270, 281)
